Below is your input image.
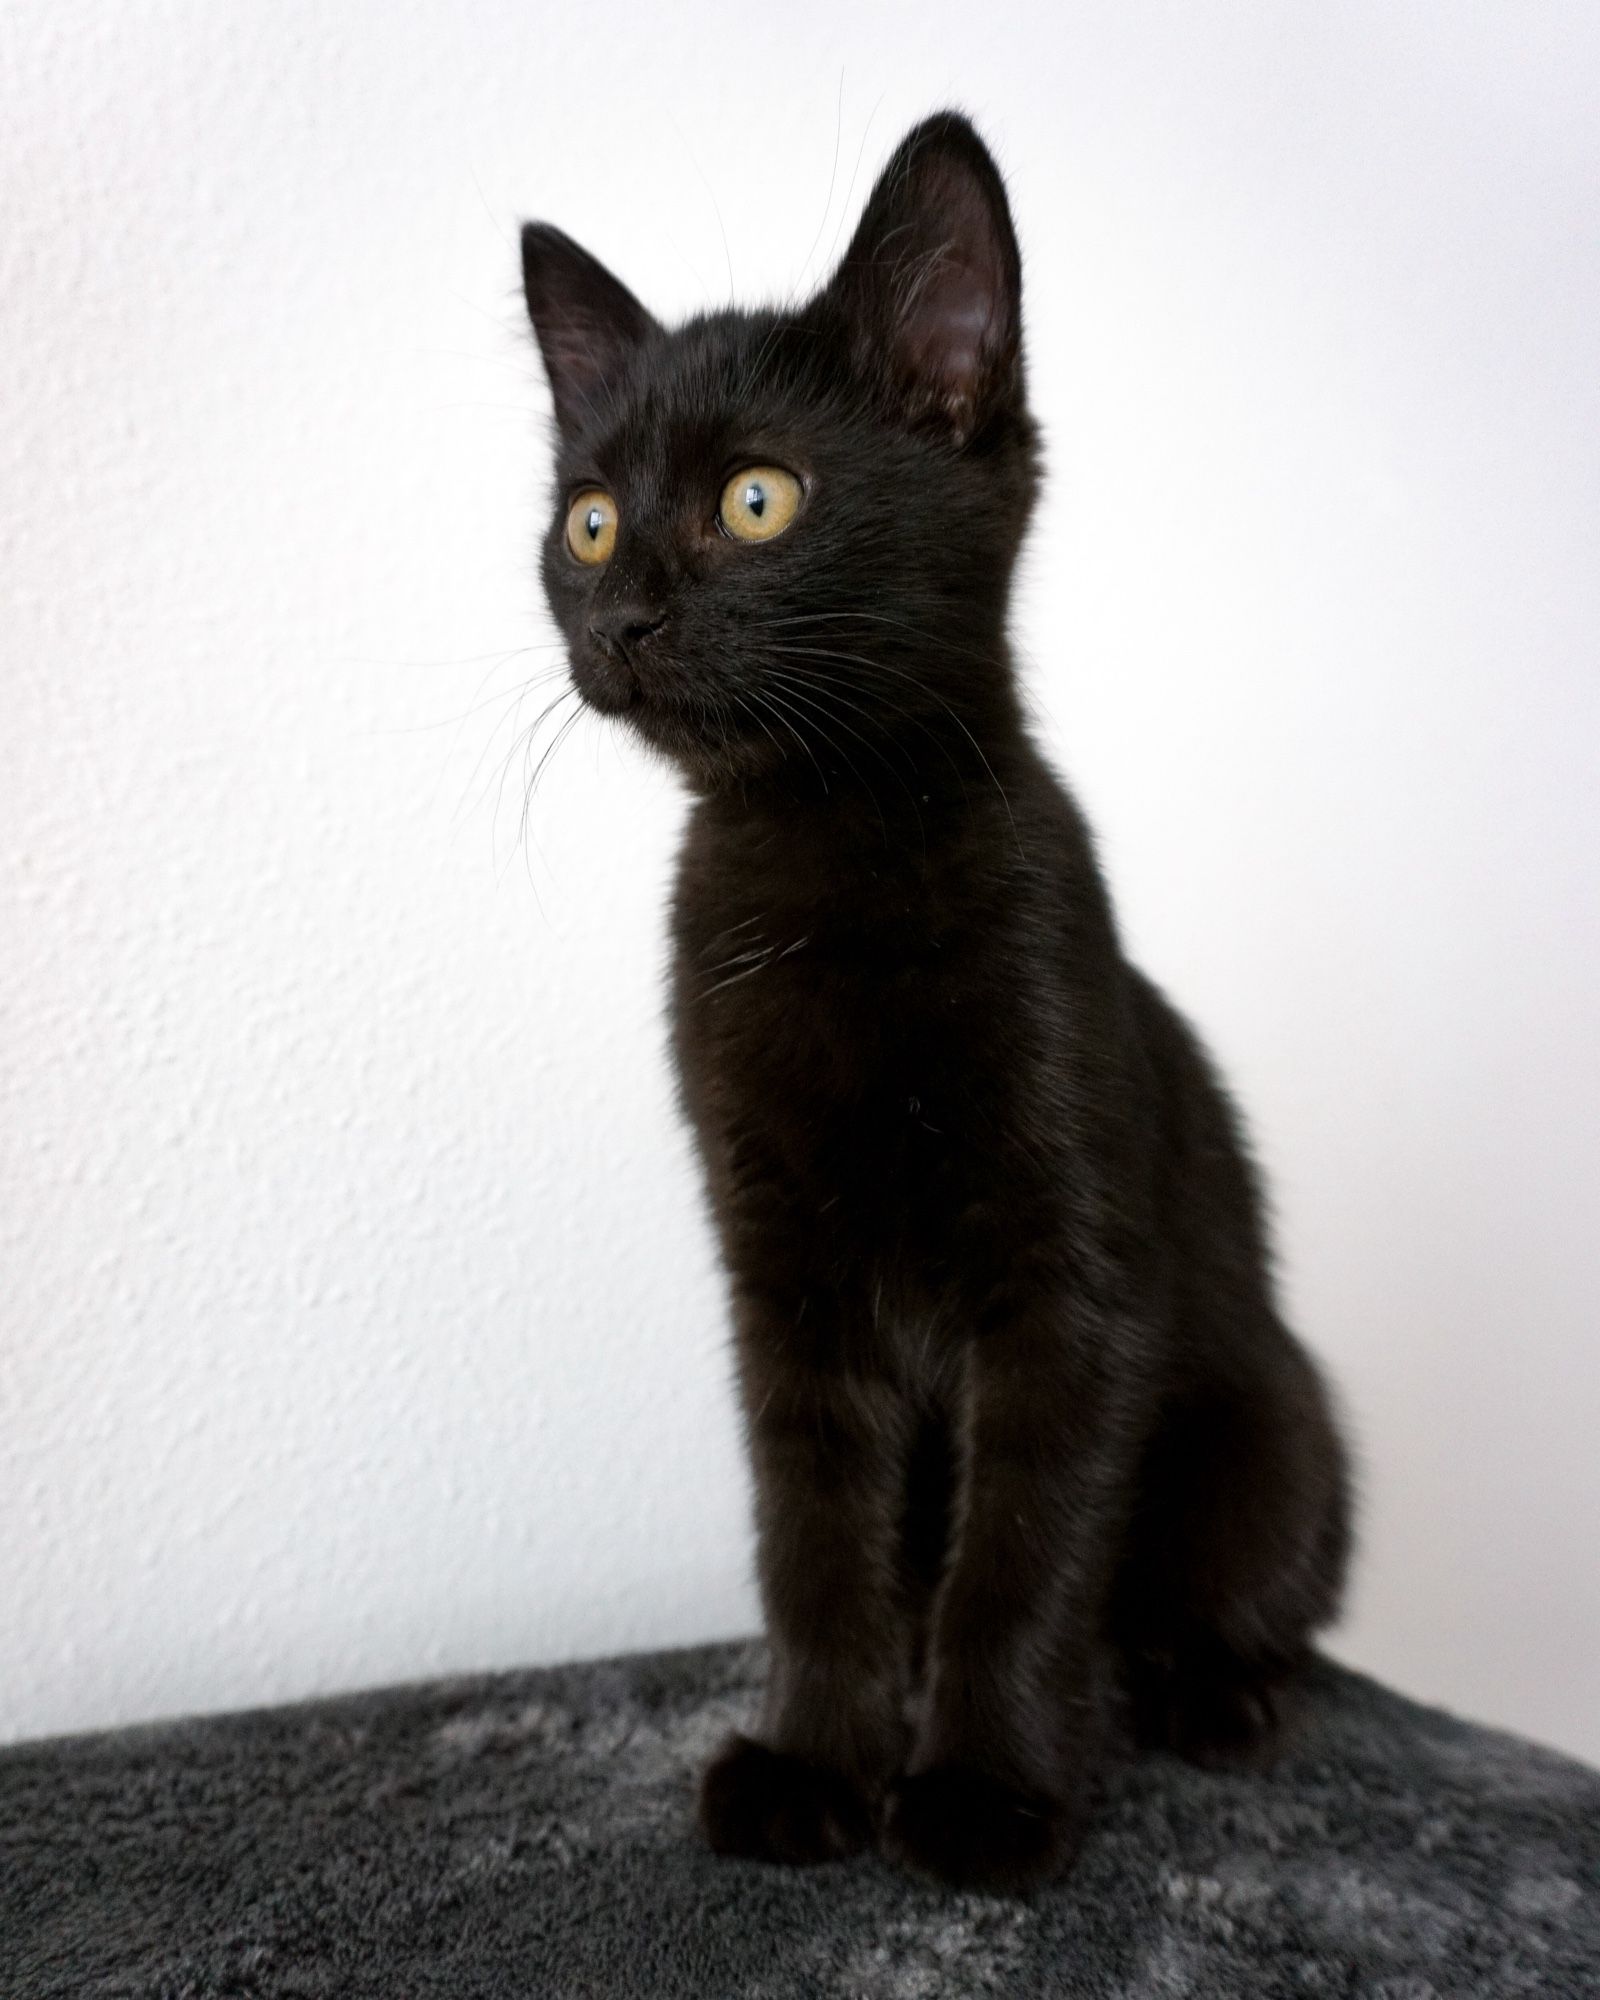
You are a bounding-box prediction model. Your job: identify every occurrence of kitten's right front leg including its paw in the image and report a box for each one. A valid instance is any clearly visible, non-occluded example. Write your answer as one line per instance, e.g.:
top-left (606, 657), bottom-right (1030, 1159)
top-left (884, 1302), bottom-right (1142, 1888)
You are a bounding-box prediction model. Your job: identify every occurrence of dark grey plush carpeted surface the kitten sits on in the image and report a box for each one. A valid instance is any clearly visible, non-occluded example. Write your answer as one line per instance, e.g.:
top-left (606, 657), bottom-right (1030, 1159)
top-left (0, 1646), bottom-right (1600, 2000)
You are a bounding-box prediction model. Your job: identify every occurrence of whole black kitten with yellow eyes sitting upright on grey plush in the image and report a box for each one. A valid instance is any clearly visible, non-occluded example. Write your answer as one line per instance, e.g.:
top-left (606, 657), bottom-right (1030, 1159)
top-left (522, 116), bottom-right (1348, 1886)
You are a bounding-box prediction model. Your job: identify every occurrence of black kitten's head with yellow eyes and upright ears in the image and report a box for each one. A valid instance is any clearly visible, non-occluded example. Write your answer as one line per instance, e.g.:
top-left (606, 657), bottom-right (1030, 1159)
top-left (522, 114), bottom-right (1034, 788)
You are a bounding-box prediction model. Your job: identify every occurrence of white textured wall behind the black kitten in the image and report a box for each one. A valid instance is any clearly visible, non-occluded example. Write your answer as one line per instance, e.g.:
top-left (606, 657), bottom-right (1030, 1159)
top-left (0, 0), bottom-right (1600, 1756)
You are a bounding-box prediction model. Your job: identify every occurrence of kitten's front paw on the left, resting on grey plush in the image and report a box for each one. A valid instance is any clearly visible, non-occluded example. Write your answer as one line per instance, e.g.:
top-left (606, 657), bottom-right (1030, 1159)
top-left (700, 1736), bottom-right (872, 1866)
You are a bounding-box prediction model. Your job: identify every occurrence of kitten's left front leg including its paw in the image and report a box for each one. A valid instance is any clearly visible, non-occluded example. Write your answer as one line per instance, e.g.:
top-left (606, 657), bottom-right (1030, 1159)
top-left (700, 1308), bottom-right (910, 1862)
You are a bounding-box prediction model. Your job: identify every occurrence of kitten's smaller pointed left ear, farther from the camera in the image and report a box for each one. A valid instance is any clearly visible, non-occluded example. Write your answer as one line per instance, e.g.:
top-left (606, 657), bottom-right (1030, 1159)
top-left (522, 222), bottom-right (660, 434)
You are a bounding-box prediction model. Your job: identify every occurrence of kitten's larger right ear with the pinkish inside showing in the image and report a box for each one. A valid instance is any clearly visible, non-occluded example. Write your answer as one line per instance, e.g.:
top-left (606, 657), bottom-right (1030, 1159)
top-left (824, 112), bottom-right (1022, 442)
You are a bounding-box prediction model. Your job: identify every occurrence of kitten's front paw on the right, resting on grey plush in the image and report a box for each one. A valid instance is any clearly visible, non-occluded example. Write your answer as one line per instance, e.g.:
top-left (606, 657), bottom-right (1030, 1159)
top-left (882, 1764), bottom-right (1076, 1892)
